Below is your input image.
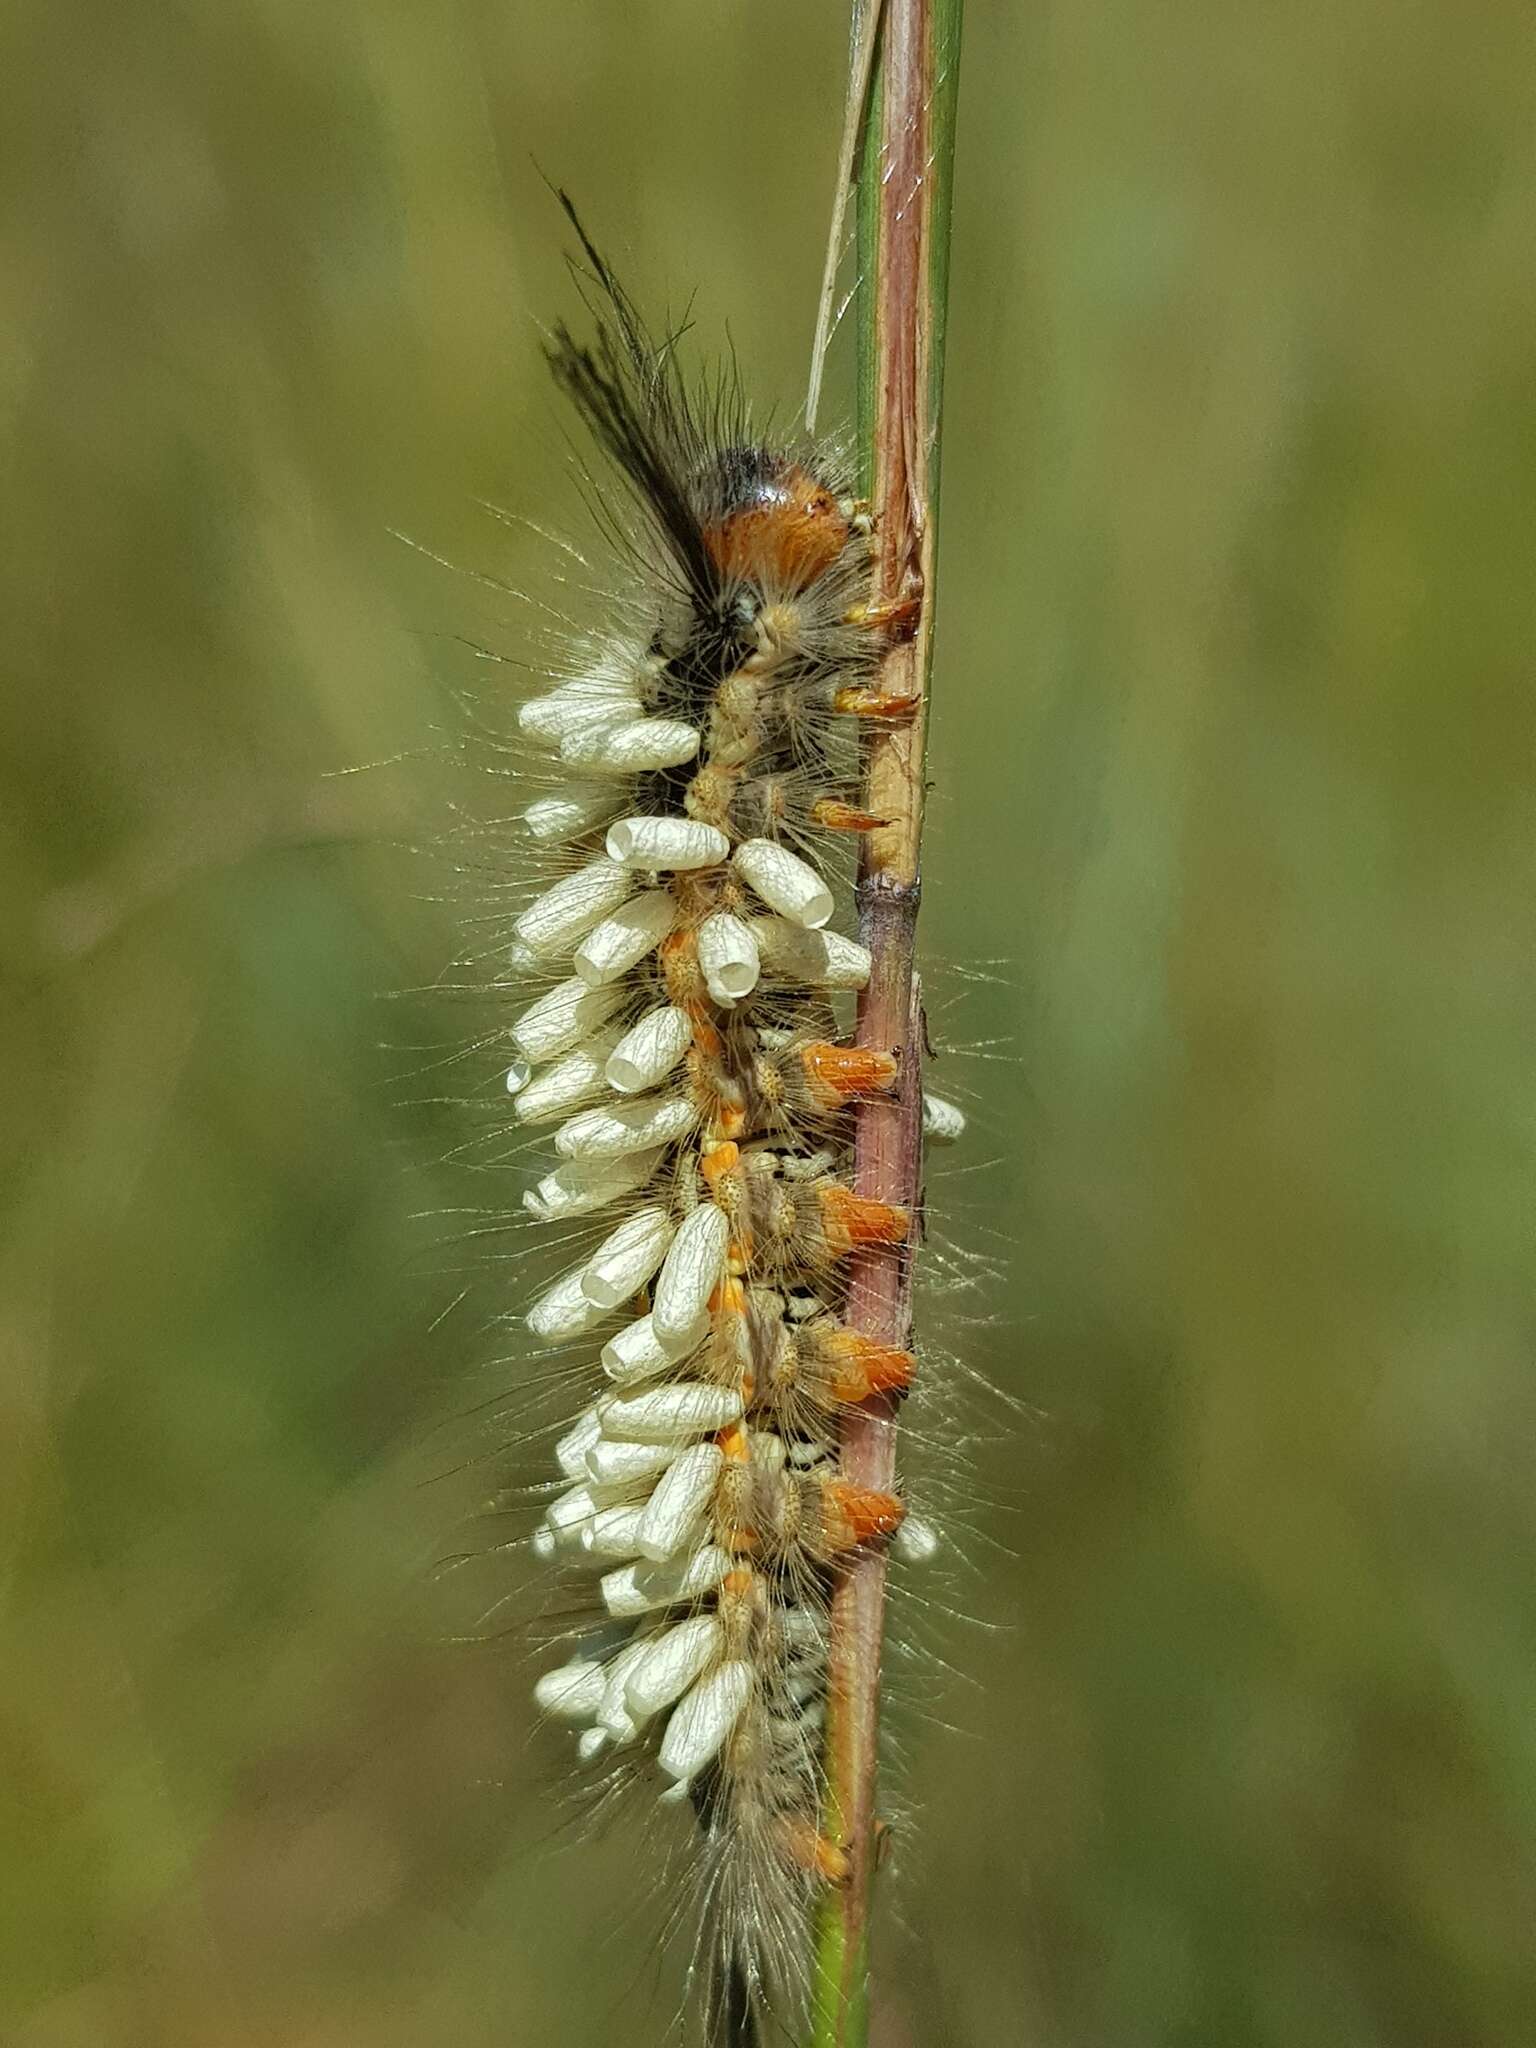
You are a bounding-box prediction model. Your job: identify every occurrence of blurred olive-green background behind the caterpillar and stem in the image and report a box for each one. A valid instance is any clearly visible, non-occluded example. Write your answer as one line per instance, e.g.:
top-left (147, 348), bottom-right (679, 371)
top-left (0, 0), bottom-right (1536, 2048)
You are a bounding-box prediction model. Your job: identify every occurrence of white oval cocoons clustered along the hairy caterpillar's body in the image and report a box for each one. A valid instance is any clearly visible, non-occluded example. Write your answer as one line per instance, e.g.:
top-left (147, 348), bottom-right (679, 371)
top-left (506, 634), bottom-right (937, 1798)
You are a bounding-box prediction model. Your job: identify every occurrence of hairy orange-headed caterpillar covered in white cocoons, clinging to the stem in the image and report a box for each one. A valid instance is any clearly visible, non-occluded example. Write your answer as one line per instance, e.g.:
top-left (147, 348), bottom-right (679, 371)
top-left (506, 205), bottom-right (956, 2040)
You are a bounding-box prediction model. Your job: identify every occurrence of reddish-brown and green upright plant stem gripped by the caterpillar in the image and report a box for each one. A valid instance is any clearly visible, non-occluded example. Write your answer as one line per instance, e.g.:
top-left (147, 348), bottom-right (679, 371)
top-left (811, 0), bottom-right (961, 2048)
